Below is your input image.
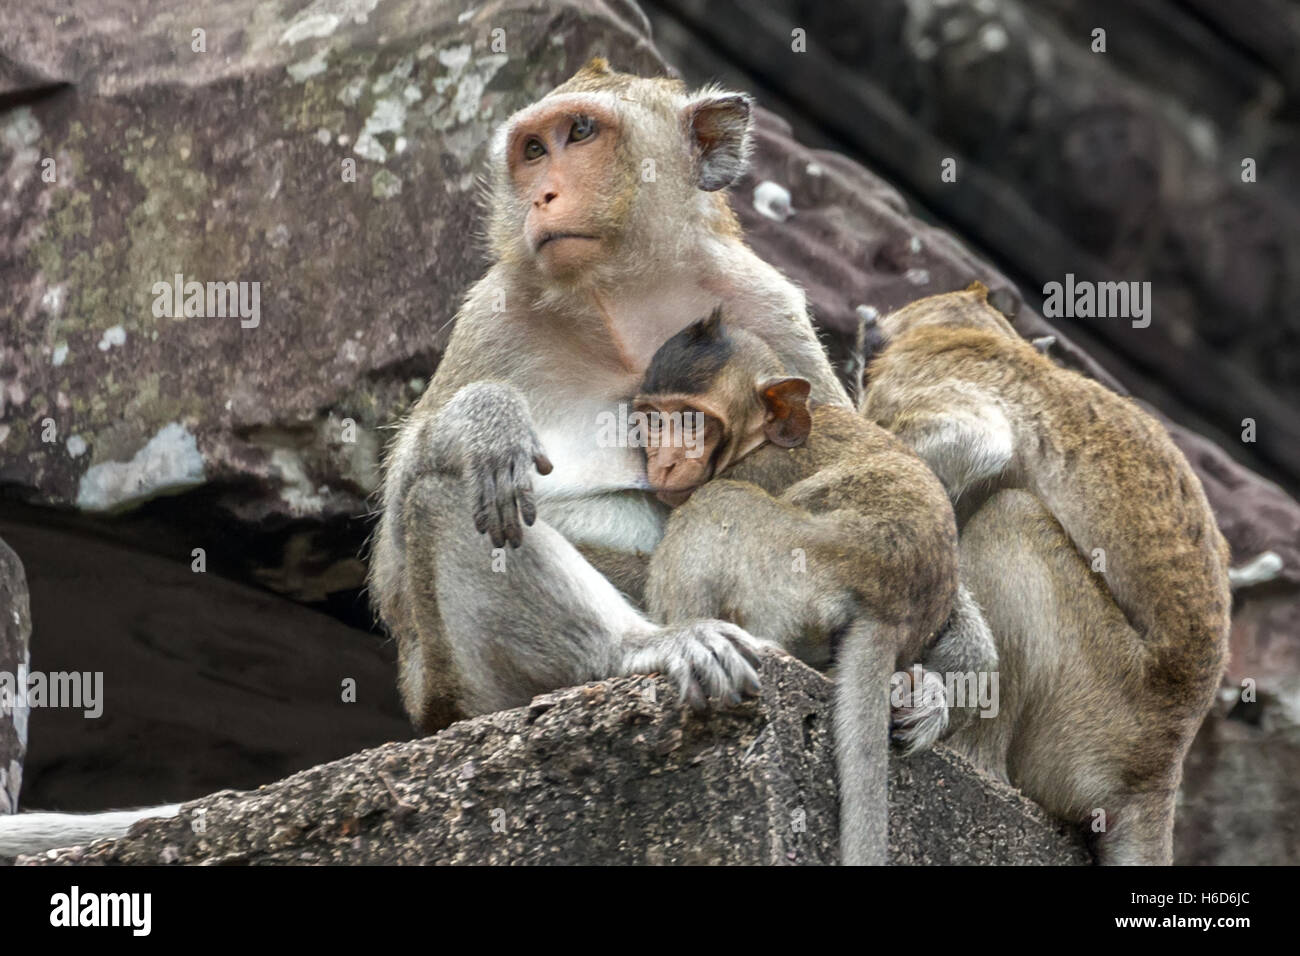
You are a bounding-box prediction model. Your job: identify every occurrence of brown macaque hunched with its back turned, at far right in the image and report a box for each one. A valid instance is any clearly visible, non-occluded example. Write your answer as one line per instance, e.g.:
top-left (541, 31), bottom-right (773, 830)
top-left (863, 284), bottom-right (1230, 864)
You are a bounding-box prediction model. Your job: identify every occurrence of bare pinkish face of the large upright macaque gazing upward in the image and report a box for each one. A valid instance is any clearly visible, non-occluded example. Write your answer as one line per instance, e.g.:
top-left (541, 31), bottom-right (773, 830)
top-left (506, 96), bottom-right (627, 277)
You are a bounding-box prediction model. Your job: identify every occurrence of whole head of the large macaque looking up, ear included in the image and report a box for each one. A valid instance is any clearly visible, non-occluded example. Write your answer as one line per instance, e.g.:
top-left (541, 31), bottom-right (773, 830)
top-left (486, 59), bottom-right (751, 278)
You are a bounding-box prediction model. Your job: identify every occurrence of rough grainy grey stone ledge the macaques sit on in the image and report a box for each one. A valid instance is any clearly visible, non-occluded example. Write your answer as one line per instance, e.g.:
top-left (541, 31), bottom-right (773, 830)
top-left (20, 657), bottom-right (1088, 864)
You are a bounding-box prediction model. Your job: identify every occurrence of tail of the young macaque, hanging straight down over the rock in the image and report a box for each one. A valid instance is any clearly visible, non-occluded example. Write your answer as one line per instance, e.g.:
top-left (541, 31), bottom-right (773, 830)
top-left (835, 620), bottom-right (905, 866)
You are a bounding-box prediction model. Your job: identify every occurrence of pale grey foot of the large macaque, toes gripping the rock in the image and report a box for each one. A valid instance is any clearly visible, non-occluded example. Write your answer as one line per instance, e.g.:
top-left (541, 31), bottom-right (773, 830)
top-left (623, 620), bottom-right (775, 711)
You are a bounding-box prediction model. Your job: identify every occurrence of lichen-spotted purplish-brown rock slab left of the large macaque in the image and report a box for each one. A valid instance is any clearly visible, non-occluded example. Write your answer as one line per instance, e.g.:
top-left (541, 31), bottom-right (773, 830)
top-left (0, 0), bottom-right (662, 520)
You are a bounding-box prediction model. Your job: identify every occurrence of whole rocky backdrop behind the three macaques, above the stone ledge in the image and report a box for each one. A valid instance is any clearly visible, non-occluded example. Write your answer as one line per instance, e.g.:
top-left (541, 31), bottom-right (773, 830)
top-left (0, 0), bottom-right (1300, 862)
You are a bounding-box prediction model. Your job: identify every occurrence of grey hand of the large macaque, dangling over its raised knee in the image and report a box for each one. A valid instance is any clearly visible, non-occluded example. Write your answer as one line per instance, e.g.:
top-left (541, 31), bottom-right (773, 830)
top-left (443, 382), bottom-right (551, 548)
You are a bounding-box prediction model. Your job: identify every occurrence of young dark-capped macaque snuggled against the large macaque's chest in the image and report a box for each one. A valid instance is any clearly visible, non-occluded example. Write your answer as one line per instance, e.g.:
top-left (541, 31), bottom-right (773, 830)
top-left (634, 311), bottom-right (983, 864)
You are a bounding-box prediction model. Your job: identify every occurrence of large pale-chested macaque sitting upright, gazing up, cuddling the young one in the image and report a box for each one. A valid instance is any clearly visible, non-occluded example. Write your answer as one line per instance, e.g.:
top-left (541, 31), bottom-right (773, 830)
top-left (371, 60), bottom-right (848, 732)
